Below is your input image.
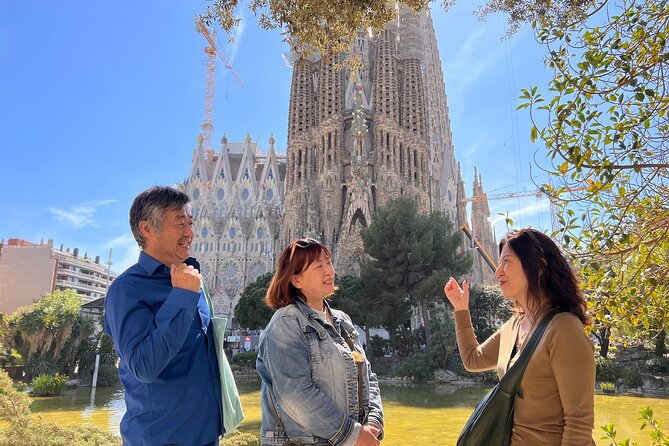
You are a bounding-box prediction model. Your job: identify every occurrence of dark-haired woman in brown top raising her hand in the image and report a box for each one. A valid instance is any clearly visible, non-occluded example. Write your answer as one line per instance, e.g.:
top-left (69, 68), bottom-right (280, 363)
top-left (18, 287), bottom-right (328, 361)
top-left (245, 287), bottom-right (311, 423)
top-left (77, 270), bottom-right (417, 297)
top-left (444, 229), bottom-right (595, 446)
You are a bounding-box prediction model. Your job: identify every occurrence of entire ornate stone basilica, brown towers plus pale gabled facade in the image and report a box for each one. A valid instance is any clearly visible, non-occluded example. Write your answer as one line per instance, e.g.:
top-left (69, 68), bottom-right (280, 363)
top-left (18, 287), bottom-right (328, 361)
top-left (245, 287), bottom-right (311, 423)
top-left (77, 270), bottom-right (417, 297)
top-left (184, 6), bottom-right (497, 315)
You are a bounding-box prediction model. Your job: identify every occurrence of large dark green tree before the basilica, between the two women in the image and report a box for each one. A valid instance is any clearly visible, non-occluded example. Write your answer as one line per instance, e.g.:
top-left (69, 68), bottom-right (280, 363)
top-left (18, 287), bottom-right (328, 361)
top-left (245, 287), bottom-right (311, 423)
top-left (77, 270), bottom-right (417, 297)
top-left (361, 196), bottom-right (472, 341)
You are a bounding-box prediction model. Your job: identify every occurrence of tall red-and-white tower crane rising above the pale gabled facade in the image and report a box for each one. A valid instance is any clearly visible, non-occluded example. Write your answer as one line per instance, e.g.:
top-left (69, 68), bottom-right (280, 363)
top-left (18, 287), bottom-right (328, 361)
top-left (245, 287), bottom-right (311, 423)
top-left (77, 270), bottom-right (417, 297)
top-left (195, 19), bottom-right (244, 153)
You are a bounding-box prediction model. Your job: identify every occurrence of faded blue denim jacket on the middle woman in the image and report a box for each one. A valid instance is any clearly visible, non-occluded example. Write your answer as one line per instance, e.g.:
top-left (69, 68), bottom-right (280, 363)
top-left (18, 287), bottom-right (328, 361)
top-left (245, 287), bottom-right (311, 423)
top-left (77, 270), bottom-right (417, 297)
top-left (256, 299), bottom-right (383, 446)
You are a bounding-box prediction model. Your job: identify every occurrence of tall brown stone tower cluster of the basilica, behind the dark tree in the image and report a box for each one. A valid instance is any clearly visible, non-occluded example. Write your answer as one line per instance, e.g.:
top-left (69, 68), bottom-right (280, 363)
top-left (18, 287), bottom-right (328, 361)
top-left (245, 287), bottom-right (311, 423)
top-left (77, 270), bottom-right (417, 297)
top-left (281, 8), bottom-right (466, 275)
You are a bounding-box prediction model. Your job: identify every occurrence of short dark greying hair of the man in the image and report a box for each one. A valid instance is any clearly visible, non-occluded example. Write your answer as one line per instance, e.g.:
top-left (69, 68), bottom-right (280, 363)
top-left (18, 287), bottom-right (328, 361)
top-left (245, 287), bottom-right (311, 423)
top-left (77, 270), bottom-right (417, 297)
top-left (130, 186), bottom-right (190, 248)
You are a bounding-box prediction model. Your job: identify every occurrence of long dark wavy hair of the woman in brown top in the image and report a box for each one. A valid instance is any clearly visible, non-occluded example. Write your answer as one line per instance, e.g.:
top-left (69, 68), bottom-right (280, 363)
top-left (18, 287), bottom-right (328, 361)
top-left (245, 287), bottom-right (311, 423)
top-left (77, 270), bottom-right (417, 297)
top-left (499, 228), bottom-right (592, 325)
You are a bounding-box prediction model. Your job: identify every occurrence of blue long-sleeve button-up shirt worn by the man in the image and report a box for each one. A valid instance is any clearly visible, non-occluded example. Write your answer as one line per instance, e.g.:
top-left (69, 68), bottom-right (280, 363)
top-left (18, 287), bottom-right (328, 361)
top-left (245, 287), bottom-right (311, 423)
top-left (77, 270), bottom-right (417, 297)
top-left (104, 252), bottom-right (223, 446)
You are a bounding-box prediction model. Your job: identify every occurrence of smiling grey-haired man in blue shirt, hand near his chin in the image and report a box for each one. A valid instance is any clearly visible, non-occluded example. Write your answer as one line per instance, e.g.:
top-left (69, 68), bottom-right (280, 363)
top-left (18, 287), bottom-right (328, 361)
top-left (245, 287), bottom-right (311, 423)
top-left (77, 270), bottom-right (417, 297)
top-left (105, 186), bottom-right (223, 446)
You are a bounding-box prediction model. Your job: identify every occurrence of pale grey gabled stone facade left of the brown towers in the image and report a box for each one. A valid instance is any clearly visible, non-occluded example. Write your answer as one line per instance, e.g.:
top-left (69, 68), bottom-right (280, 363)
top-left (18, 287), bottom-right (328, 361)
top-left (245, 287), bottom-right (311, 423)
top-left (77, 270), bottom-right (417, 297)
top-left (184, 135), bottom-right (286, 316)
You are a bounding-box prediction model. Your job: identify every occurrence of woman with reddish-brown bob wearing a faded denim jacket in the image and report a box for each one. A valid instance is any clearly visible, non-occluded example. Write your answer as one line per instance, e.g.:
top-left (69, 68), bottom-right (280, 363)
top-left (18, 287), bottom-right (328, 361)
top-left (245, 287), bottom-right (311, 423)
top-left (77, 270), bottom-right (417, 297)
top-left (256, 239), bottom-right (383, 446)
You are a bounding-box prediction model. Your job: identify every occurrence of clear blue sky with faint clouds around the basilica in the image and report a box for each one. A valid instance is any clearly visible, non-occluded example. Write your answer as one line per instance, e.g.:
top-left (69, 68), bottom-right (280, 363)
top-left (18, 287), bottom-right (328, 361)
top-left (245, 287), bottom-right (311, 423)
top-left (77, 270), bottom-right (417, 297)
top-left (0, 0), bottom-right (550, 271)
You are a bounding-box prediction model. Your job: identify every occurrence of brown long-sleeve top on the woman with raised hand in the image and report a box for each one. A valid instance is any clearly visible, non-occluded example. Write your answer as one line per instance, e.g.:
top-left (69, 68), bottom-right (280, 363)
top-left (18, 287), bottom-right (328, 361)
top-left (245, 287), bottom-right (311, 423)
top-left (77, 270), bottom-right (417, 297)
top-left (455, 310), bottom-right (595, 446)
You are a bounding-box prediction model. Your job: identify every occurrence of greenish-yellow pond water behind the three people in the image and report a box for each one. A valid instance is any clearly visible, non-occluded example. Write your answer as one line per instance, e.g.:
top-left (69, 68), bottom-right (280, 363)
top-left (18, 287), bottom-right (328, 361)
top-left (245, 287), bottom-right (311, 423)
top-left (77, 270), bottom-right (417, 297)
top-left (31, 380), bottom-right (669, 446)
